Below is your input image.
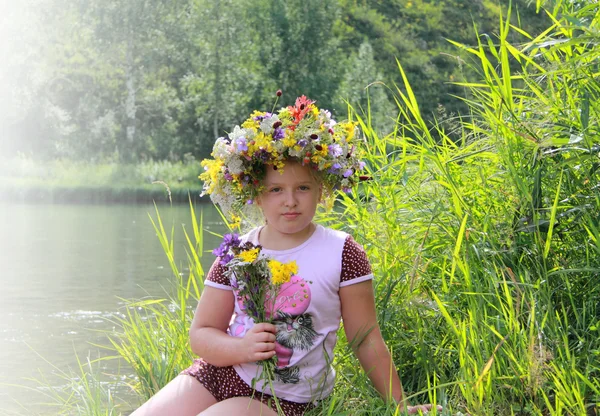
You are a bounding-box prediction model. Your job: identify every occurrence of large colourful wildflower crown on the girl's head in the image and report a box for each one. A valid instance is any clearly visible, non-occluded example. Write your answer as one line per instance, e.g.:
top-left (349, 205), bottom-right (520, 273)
top-left (200, 93), bottom-right (365, 215)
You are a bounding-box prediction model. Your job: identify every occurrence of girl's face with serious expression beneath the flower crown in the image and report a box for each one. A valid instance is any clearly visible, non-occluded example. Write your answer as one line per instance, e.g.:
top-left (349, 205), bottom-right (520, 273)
top-left (257, 162), bottom-right (322, 237)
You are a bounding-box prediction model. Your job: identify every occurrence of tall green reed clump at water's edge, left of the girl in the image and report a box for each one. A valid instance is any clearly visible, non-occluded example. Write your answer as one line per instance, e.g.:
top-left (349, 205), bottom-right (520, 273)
top-left (111, 200), bottom-right (204, 400)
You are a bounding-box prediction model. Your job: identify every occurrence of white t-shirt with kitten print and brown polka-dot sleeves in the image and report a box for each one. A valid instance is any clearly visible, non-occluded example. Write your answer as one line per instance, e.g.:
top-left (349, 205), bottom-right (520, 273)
top-left (205, 225), bottom-right (373, 403)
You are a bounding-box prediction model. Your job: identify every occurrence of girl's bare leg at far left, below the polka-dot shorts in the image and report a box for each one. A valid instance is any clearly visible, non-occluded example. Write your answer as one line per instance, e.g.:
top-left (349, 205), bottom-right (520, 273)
top-left (130, 375), bottom-right (218, 416)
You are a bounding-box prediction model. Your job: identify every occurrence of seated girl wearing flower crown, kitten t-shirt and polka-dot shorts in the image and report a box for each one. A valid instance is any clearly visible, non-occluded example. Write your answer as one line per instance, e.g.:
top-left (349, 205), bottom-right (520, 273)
top-left (134, 96), bottom-right (441, 416)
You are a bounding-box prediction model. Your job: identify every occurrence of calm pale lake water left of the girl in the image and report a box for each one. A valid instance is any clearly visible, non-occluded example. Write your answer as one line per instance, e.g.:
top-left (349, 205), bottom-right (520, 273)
top-left (0, 203), bottom-right (224, 415)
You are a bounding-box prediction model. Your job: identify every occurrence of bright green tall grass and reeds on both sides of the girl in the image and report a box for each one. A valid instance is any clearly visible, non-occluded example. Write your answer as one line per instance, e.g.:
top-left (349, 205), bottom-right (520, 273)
top-left (43, 2), bottom-right (600, 416)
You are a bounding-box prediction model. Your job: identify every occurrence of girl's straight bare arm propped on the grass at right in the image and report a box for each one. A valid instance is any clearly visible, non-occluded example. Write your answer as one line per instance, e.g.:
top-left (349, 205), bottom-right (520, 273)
top-left (340, 280), bottom-right (442, 414)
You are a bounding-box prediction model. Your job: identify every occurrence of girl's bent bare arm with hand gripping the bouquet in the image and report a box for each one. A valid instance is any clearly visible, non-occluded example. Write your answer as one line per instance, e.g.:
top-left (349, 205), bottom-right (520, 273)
top-left (190, 286), bottom-right (275, 367)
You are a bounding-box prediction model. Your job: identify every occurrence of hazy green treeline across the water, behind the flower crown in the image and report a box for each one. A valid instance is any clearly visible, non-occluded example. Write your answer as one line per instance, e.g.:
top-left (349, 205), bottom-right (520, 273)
top-left (0, 0), bottom-right (547, 162)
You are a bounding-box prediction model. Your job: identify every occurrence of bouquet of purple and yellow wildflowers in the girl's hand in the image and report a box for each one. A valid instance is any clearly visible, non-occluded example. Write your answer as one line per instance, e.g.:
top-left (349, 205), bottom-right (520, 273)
top-left (213, 234), bottom-right (298, 390)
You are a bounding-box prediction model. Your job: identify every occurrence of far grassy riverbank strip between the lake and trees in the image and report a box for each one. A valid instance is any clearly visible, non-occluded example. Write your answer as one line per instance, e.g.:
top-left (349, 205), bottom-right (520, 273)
top-left (0, 157), bottom-right (209, 204)
